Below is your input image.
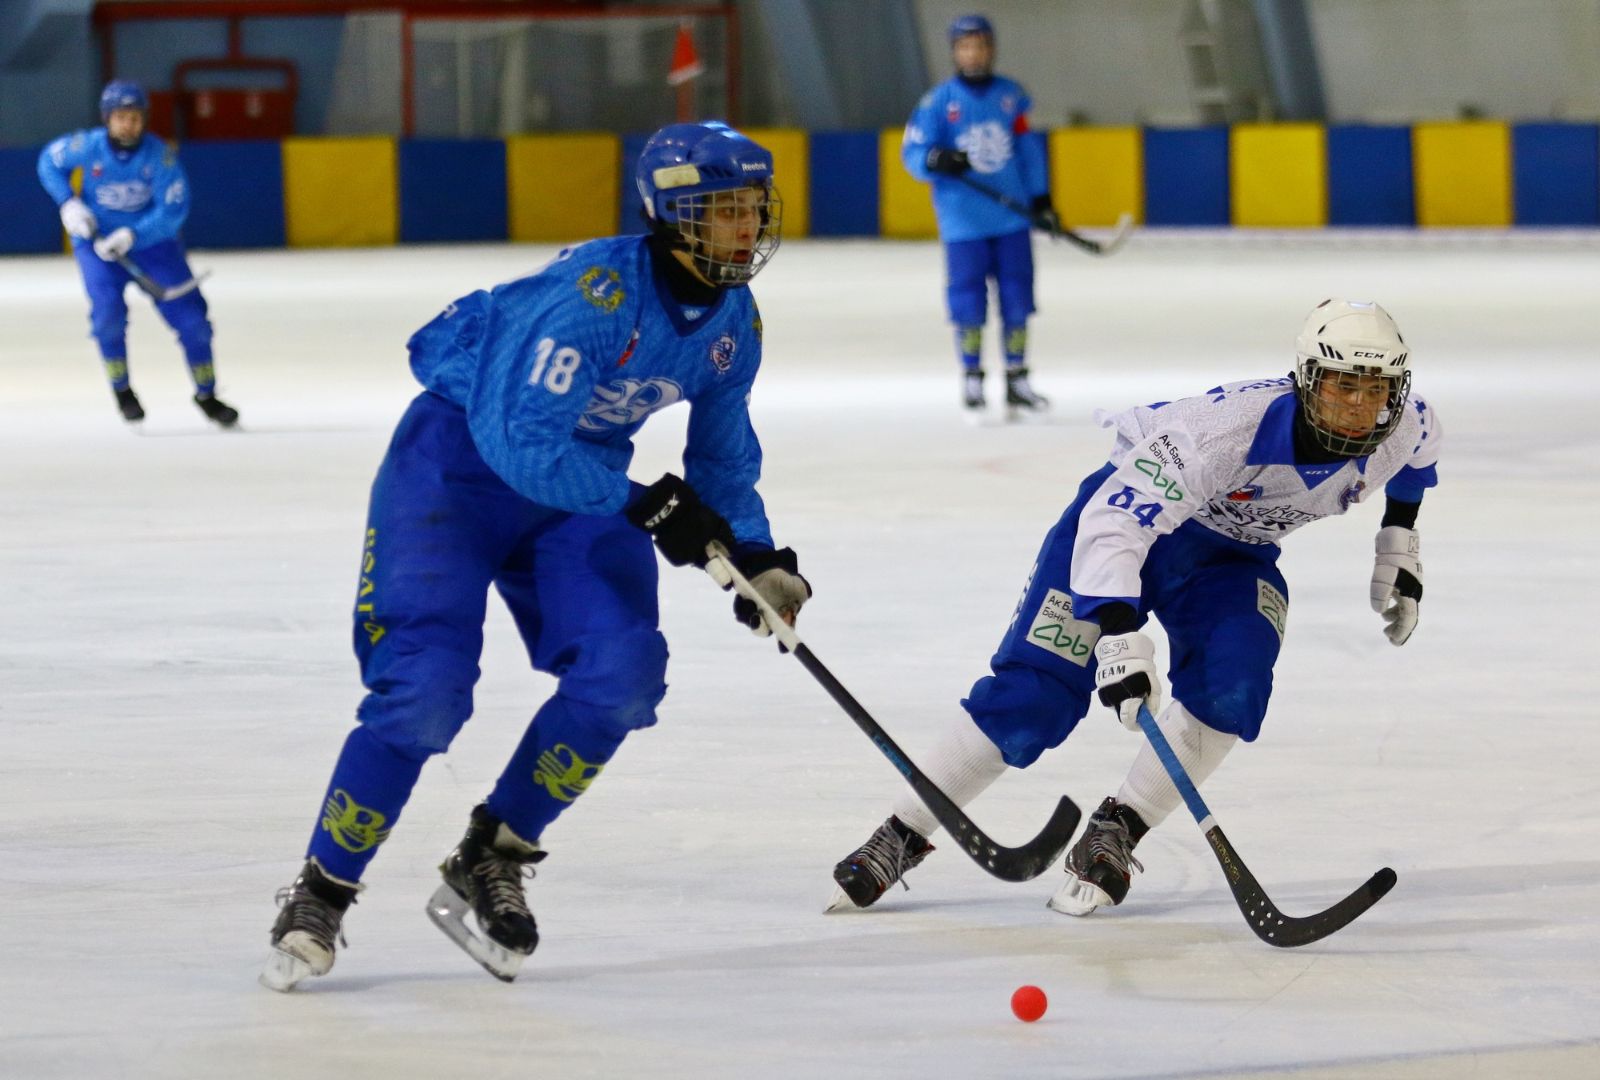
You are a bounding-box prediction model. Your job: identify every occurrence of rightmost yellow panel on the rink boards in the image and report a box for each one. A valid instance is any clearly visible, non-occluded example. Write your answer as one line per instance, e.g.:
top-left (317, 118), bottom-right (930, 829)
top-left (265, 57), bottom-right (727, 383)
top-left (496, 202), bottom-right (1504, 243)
top-left (1411, 120), bottom-right (1512, 226)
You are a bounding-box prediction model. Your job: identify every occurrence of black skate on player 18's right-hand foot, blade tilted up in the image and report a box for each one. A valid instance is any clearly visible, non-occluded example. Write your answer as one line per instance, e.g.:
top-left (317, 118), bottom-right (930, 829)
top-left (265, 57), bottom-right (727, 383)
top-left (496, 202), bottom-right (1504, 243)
top-left (427, 803), bottom-right (546, 982)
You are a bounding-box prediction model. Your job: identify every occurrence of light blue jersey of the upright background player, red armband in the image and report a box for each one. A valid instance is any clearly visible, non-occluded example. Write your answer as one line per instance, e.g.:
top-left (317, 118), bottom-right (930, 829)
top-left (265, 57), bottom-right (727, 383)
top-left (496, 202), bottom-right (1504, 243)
top-left (901, 75), bottom-right (1050, 242)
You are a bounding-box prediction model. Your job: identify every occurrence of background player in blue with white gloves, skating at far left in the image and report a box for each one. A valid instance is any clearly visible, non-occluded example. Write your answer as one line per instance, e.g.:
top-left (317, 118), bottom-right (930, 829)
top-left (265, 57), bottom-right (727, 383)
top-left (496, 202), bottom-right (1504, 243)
top-left (38, 80), bottom-right (238, 427)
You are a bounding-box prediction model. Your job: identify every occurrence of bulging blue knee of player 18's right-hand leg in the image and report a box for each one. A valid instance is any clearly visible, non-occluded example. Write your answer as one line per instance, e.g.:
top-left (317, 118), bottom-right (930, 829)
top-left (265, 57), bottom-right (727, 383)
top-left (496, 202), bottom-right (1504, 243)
top-left (555, 629), bottom-right (667, 733)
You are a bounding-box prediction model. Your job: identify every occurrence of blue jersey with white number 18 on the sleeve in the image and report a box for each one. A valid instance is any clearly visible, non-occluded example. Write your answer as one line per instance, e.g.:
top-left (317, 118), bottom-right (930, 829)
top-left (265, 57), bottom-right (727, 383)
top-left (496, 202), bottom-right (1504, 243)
top-left (410, 237), bottom-right (773, 547)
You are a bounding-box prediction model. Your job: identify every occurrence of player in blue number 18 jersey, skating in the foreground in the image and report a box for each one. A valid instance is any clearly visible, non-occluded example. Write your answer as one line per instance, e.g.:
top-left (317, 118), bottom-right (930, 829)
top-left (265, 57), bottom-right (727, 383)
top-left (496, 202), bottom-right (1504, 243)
top-left (262, 123), bottom-right (811, 990)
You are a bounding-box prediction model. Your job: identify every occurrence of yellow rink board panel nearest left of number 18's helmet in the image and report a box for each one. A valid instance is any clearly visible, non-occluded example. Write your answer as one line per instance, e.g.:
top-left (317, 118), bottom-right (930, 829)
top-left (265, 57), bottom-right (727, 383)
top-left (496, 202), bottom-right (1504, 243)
top-left (506, 133), bottom-right (620, 243)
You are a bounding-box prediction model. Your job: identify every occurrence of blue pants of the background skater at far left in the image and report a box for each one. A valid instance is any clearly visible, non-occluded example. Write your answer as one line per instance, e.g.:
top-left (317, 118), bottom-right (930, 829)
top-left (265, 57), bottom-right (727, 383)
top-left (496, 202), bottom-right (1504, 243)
top-left (72, 240), bottom-right (216, 394)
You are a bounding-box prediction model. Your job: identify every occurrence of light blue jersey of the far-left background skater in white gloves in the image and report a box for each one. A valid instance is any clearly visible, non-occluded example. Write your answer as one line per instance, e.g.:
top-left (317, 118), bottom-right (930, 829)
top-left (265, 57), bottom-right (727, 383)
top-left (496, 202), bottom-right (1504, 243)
top-left (38, 128), bottom-right (189, 251)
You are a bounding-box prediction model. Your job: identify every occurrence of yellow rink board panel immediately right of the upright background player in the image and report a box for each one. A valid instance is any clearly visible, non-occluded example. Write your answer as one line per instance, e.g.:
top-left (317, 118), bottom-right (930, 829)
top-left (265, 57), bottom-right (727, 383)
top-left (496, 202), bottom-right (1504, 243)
top-left (1050, 128), bottom-right (1144, 227)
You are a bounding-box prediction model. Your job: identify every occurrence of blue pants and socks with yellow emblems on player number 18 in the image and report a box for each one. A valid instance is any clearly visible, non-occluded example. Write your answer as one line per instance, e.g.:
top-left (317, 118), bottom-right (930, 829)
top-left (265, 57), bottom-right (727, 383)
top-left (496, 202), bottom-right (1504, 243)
top-left (309, 394), bottom-right (667, 882)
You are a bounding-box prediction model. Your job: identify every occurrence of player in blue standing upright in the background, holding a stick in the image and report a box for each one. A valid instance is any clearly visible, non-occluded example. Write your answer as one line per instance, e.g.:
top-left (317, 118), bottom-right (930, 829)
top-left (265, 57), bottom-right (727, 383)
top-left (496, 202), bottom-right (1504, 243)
top-left (901, 14), bottom-right (1061, 413)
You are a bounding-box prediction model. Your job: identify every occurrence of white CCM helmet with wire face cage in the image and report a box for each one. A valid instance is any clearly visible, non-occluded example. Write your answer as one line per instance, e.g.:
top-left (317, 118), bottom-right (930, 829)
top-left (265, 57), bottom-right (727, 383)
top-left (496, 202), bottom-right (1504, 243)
top-left (1294, 299), bottom-right (1411, 458)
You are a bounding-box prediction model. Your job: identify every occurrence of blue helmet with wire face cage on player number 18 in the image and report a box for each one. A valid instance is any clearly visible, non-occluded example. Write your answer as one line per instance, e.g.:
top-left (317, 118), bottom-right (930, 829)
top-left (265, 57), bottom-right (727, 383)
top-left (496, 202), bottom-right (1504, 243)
top-left (634, 120), bottom-right (782, 285)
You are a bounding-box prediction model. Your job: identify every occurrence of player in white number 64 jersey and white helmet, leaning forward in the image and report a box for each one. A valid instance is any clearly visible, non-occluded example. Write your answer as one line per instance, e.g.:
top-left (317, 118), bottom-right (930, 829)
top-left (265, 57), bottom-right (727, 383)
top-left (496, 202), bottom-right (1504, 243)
top-left (834, 299), bottom-right (1440, 915)
